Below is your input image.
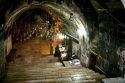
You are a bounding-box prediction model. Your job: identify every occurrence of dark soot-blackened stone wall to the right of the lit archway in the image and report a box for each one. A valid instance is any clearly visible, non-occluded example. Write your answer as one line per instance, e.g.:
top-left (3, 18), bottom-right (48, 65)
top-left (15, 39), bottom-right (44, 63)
top-left (79, 0), bottom-right (125, 76)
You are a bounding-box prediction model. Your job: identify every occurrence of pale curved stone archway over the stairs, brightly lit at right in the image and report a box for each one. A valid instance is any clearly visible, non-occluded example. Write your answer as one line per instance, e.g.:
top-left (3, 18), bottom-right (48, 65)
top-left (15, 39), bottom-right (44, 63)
top-left (4, 2), bottom-right (89, 65)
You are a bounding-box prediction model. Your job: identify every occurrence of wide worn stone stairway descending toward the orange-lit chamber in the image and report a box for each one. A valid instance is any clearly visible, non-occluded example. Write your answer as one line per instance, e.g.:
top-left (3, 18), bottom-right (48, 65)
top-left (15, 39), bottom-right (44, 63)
top-left (4, 56), bottom-right (105, 83)
